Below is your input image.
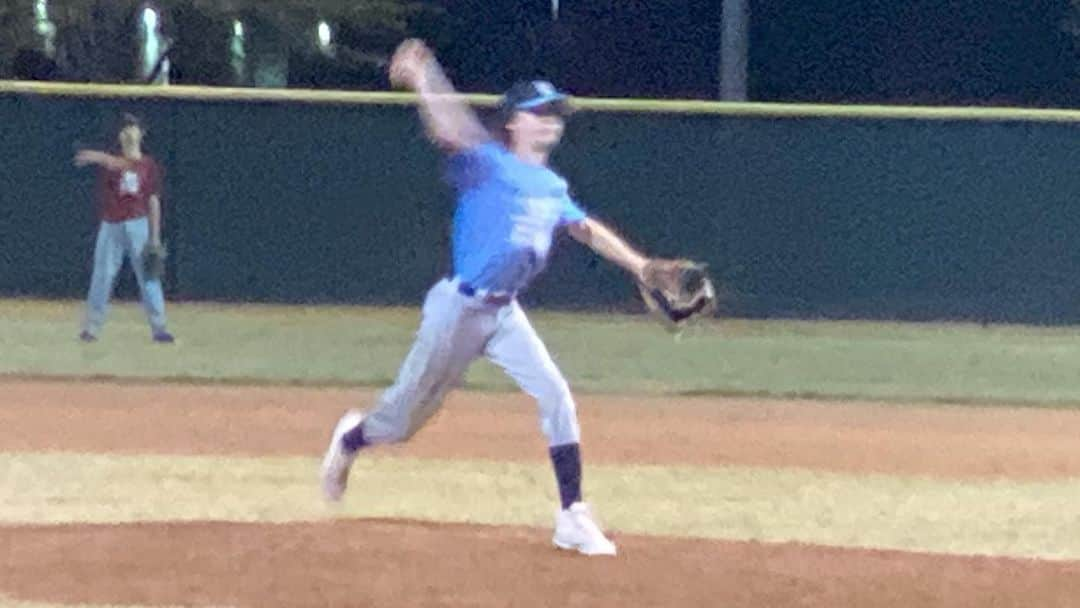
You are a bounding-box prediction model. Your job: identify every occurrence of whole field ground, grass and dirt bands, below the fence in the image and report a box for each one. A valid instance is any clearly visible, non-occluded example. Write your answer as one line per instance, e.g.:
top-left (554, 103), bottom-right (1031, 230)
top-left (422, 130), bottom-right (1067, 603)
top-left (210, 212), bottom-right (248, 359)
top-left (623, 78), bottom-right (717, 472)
top-left (0, 300), bottom-right (1080, 608)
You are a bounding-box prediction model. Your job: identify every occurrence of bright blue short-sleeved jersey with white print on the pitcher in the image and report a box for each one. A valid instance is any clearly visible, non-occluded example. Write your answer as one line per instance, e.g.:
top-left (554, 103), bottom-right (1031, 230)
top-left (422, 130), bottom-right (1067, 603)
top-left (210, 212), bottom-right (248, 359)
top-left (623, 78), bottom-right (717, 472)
top-left (447, 141), bottom-right (586, 293)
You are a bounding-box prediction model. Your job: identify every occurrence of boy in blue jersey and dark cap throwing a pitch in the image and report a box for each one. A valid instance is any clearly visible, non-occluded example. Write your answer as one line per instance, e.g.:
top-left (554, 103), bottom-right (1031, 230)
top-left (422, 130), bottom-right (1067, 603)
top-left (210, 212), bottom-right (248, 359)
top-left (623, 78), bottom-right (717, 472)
top-left (321, 40), bottom-right (648, 555)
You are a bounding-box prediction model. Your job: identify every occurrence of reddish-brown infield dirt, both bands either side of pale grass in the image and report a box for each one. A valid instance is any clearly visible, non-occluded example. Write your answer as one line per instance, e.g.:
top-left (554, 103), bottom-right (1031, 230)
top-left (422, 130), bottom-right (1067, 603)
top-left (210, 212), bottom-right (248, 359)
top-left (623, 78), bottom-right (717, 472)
top-left (0, 380), bottom-right (1080, 608)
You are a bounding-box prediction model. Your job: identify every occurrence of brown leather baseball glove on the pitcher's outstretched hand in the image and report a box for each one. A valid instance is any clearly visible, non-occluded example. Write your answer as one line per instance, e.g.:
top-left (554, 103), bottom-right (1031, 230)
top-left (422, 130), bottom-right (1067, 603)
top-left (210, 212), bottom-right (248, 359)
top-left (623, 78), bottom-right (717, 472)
top-left (637, 258), bottom-right (716, 328)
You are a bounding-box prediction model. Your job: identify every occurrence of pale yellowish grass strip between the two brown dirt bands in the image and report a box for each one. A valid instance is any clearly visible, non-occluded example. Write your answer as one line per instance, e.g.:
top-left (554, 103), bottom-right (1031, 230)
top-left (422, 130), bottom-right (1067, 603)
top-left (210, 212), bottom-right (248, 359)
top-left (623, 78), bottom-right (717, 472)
top-left (0, 454), bottom-right (1080, 559)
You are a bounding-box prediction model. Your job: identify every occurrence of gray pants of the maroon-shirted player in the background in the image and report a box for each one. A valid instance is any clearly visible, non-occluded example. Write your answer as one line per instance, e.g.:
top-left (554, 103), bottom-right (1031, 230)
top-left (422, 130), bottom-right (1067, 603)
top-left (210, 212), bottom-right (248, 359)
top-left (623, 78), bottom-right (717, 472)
top-left (82, 217), bottom-right (165, 336)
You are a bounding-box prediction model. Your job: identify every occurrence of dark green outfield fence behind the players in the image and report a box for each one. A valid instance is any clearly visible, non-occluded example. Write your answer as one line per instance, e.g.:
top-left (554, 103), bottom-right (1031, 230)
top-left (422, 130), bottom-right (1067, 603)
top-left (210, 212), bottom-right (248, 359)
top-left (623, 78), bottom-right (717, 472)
top-left (0, 83), bottom-right (1080, 323)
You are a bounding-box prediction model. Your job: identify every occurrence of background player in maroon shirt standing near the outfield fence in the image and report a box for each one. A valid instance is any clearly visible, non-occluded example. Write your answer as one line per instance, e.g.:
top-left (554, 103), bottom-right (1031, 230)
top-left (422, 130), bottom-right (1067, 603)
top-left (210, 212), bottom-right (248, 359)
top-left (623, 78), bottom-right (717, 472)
top-left (75, 113), bottom-right (173, 343)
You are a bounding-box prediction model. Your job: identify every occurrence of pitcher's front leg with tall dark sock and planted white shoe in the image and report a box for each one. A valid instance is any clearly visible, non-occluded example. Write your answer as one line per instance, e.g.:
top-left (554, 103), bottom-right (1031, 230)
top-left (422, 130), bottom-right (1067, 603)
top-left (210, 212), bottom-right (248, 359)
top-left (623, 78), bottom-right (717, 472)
top-left (486, 302), bottom-right (616, 555)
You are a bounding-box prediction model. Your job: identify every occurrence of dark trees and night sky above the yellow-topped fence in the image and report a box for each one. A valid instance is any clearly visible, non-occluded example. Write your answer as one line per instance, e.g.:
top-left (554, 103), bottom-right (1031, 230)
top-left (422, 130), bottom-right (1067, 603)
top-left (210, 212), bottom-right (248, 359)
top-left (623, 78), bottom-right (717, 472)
top-left (8, 0), bottom-right (1080, 107)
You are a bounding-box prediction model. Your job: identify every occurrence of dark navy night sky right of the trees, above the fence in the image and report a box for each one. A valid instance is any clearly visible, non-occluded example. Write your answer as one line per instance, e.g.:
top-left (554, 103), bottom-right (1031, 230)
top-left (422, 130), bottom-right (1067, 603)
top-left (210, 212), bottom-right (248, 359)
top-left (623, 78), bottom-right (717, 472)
top-left (436, 0), bottom-right (1080, 107)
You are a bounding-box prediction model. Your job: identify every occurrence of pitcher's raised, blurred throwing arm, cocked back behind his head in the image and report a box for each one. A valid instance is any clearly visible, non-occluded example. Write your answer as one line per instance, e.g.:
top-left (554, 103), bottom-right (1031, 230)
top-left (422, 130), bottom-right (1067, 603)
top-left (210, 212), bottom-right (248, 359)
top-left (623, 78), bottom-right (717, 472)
top-left (390, 39), bottom-right (491, 151)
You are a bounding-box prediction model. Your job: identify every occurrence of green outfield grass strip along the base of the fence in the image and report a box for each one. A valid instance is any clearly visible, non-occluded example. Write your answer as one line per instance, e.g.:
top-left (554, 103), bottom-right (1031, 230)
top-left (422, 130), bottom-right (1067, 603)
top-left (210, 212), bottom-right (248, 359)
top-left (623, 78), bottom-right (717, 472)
top-left (0, 300), bottom-right (1080, 405)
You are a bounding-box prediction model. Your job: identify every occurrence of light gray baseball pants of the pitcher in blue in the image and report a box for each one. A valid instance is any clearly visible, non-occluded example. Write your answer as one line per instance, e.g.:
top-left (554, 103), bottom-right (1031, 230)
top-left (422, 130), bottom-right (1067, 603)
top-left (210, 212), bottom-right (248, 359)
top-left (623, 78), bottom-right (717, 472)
top-left (364, 280), bottom-right (581, 446)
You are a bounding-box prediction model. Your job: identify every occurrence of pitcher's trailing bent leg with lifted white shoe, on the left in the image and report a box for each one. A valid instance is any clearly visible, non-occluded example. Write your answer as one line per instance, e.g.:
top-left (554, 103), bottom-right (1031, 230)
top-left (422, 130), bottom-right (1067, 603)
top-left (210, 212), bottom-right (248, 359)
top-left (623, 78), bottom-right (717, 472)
top-left (322, 281), bottom-right (495, 500)
